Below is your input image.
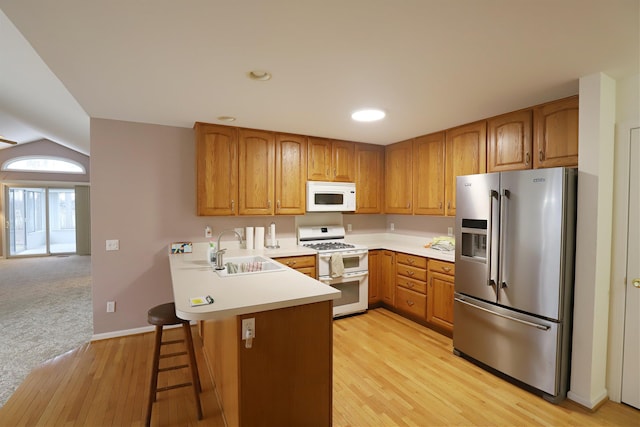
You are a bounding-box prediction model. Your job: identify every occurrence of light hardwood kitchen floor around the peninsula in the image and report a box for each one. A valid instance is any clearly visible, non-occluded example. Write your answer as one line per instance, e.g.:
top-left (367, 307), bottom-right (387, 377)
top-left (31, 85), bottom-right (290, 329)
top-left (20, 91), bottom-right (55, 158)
top-left (0, 309), bottom-right (640, 427)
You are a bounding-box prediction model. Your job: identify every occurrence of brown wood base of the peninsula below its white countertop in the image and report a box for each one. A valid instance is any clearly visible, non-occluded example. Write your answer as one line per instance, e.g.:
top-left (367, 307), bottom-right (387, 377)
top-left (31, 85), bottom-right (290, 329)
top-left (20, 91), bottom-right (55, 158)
top-left (200, 301), bottom-right (333, 427)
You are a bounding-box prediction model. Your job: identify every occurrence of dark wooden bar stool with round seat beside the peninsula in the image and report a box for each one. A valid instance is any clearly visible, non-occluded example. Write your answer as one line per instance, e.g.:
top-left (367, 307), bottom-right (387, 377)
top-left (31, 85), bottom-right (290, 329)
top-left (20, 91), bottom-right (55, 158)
top-left (146, 302), bottom-right (202, 426)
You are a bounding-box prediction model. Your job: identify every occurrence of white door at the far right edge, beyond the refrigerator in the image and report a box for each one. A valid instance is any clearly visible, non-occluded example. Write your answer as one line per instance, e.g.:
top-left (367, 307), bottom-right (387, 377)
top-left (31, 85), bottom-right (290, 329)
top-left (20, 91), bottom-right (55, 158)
top-left (621, 128), bottom-right (640, 409)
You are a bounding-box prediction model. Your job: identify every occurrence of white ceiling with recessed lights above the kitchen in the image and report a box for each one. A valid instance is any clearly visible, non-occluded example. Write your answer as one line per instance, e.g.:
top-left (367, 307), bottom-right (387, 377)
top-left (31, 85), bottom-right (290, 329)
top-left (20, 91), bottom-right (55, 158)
top-left (0, 0), bottom-right (640, 153)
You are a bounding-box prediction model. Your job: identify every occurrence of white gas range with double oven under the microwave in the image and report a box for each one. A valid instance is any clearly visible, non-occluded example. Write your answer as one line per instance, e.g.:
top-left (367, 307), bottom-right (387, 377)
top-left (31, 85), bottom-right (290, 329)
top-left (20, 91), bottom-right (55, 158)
top-left (298, 225), bottom-right (369, 317)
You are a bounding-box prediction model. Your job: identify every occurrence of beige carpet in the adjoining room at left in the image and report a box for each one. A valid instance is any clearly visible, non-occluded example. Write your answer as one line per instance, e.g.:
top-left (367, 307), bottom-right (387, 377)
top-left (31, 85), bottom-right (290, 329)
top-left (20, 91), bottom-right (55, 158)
top-left (0, 255), bottom-right (93, 406)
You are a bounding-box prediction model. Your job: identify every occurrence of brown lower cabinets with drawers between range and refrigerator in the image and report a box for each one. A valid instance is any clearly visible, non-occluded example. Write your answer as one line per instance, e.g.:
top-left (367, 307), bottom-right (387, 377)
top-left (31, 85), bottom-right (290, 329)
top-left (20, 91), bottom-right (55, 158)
top-left (369, 250), bottom-right (455, 336)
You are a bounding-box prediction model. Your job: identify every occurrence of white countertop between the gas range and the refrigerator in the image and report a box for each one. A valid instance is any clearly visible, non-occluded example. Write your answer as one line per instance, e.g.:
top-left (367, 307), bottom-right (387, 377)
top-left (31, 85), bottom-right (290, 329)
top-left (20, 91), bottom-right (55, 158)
top-left (345, 233), bottom-right (455, 262)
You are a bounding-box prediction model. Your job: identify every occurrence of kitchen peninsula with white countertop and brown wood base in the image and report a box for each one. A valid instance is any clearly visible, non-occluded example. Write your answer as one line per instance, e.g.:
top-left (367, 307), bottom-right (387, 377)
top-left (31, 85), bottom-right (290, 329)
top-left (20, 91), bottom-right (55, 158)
top-left (169, 244), bottom-right (340, 426)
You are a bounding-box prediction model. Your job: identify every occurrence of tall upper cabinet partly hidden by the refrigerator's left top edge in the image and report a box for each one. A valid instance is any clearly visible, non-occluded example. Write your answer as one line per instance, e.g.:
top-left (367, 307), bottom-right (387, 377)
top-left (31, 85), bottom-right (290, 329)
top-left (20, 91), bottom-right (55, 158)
top-left (444, 120), bottom-right (487, 216)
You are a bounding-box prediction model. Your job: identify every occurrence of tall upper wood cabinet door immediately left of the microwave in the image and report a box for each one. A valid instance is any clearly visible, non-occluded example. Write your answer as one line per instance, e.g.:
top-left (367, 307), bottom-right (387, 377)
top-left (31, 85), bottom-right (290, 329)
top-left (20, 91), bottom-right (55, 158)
top-left (275, 134), bottom-right (307, 215)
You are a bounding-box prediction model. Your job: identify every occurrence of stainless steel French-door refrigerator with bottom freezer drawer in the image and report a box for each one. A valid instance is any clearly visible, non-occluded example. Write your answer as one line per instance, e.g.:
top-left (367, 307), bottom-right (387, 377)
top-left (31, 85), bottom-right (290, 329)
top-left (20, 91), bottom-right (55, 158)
top-left (453, 168), bottom-right (577, 402)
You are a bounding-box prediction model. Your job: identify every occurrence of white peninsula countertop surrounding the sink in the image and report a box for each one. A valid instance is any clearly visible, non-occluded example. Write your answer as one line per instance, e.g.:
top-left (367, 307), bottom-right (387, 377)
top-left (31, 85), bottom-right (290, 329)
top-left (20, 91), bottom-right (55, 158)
top-left (169, 244), bottom-right (340, 320)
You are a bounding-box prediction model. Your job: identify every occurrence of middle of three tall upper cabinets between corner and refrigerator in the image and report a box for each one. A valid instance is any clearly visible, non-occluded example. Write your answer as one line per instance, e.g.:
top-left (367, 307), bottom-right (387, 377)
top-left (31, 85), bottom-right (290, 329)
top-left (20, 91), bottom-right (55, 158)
top-left (413, 132), bottom-right (445, 215)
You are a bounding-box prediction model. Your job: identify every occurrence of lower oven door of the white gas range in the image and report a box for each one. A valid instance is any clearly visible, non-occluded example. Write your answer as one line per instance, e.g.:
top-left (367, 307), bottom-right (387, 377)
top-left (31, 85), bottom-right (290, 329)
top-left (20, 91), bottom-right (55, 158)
top-left (318, 271), bottom-right (369, 317)
